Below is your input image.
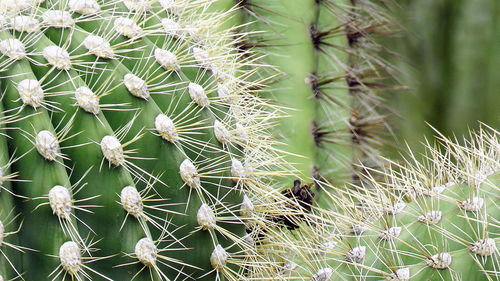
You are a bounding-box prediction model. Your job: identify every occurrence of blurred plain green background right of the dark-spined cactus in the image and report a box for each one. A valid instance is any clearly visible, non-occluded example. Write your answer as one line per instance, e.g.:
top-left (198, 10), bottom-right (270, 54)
top-left (384, 0), bottom-right (500, 152)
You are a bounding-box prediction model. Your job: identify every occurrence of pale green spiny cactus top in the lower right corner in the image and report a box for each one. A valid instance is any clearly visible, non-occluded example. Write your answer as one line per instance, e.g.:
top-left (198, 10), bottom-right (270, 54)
top-left (273, 125), bottom-right (500, 281)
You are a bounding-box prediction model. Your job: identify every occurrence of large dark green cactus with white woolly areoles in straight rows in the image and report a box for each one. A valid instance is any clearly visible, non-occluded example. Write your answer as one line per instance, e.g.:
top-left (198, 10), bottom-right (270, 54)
top-left (0, 0), bottom-right (296, 280)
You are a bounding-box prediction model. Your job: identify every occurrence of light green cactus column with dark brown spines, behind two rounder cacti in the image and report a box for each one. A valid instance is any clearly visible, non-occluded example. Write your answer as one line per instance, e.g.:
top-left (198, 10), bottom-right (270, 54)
top-left (237, 0), bottom-right (394, 188)
